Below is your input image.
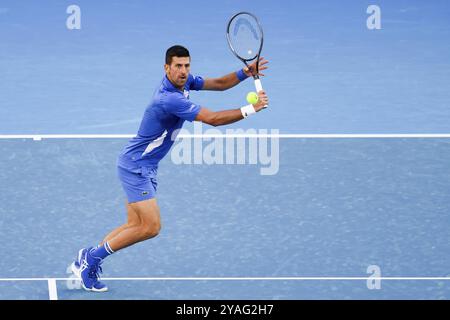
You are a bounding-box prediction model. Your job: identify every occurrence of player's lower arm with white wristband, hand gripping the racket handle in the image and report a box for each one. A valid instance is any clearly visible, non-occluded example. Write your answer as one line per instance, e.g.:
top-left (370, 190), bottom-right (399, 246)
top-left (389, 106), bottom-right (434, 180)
top-left (195, 91), bottom-right (269, 127)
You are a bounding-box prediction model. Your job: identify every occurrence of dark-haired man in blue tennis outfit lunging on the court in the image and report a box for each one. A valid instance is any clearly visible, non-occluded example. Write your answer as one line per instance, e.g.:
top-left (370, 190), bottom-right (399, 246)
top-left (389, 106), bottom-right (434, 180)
top-left (71, 45), bottom-right (269, 292)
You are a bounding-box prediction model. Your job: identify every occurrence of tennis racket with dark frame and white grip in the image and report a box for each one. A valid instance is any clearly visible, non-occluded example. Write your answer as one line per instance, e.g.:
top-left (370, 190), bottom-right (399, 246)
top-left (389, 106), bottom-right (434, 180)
top-left (227, 12), bottom-right (266, 107)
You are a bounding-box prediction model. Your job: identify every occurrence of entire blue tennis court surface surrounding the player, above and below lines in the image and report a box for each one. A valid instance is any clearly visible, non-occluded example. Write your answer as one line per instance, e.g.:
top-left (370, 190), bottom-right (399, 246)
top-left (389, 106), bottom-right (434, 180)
top-left (0, 1), bottom-right (450, 299)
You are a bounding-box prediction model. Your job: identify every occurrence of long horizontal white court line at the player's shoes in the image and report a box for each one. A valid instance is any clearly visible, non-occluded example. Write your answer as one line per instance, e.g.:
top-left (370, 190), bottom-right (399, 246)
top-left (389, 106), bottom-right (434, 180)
top-left (0, 276), bottom-right (450, 287)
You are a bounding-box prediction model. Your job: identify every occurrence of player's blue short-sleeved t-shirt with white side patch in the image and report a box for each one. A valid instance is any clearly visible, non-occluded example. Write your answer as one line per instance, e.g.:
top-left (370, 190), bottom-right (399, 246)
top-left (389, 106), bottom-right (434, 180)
top-left (118, 75), bottom-right (204, 168)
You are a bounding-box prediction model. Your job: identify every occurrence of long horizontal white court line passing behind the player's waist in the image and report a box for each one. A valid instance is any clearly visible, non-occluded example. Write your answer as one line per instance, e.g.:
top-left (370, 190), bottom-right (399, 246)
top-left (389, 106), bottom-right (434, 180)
top-left (0, 133), bottom-right (450, 141)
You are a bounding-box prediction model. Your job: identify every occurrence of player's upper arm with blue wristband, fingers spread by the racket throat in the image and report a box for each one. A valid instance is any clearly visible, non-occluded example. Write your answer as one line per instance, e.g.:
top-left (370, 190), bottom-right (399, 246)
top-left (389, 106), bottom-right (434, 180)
top-left (202, 58), bottom-right (269, 91)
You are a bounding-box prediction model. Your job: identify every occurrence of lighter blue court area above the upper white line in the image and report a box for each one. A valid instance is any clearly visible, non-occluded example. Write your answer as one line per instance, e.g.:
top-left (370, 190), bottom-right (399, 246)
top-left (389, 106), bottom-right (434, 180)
top-left (0, 0), bottom-right (450, 134)
